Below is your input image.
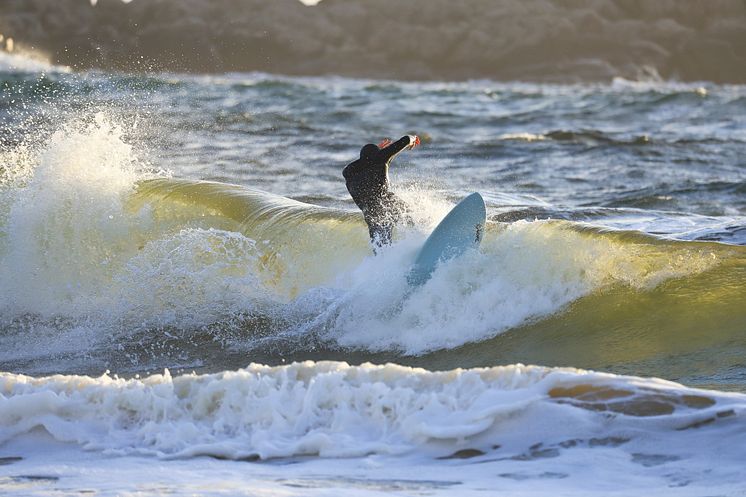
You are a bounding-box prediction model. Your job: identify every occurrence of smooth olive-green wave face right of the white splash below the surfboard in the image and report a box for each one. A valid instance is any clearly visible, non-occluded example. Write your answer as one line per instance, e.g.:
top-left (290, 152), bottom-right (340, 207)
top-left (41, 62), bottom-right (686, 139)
top-left (418, 227), bottom-right (746, 390)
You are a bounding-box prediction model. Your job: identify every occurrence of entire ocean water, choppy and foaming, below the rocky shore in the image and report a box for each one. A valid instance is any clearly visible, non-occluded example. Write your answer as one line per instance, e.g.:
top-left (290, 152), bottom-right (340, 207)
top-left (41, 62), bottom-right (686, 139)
top-left (0, 55), bottom-right (746, 496)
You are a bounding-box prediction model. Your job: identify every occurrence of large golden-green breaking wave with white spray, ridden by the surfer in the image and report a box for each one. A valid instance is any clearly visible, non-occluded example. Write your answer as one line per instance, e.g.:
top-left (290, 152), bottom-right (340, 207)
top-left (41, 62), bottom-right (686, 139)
top-left (0, 115), bottom-right (746, 380)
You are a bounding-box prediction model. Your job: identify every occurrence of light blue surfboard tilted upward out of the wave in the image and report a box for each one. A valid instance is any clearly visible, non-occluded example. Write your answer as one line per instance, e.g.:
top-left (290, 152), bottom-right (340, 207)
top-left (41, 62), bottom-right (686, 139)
top-left (407, 193), bottom-right (487, 286)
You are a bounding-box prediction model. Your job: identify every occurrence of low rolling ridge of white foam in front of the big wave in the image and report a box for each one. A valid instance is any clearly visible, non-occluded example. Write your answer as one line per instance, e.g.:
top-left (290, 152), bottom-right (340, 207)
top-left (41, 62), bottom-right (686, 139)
top-left (0, 362), bottom-right (746, 459)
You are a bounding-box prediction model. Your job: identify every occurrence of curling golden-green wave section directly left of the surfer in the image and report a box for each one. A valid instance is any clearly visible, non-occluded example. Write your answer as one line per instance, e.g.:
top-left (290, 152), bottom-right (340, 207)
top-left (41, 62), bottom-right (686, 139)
top-left (128, 179), bottom-right (370, 299)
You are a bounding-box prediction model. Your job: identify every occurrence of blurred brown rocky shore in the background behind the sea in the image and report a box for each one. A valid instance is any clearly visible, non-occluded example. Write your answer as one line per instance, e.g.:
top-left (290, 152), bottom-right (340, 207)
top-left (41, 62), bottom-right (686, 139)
top-left (0, 0), bottom-right (746, 83)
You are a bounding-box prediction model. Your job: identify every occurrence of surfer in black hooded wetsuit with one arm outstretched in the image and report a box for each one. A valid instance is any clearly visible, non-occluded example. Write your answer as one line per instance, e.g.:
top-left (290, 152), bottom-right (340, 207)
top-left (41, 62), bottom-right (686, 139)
top-left (342, 135), bottom-right (420, 251)
